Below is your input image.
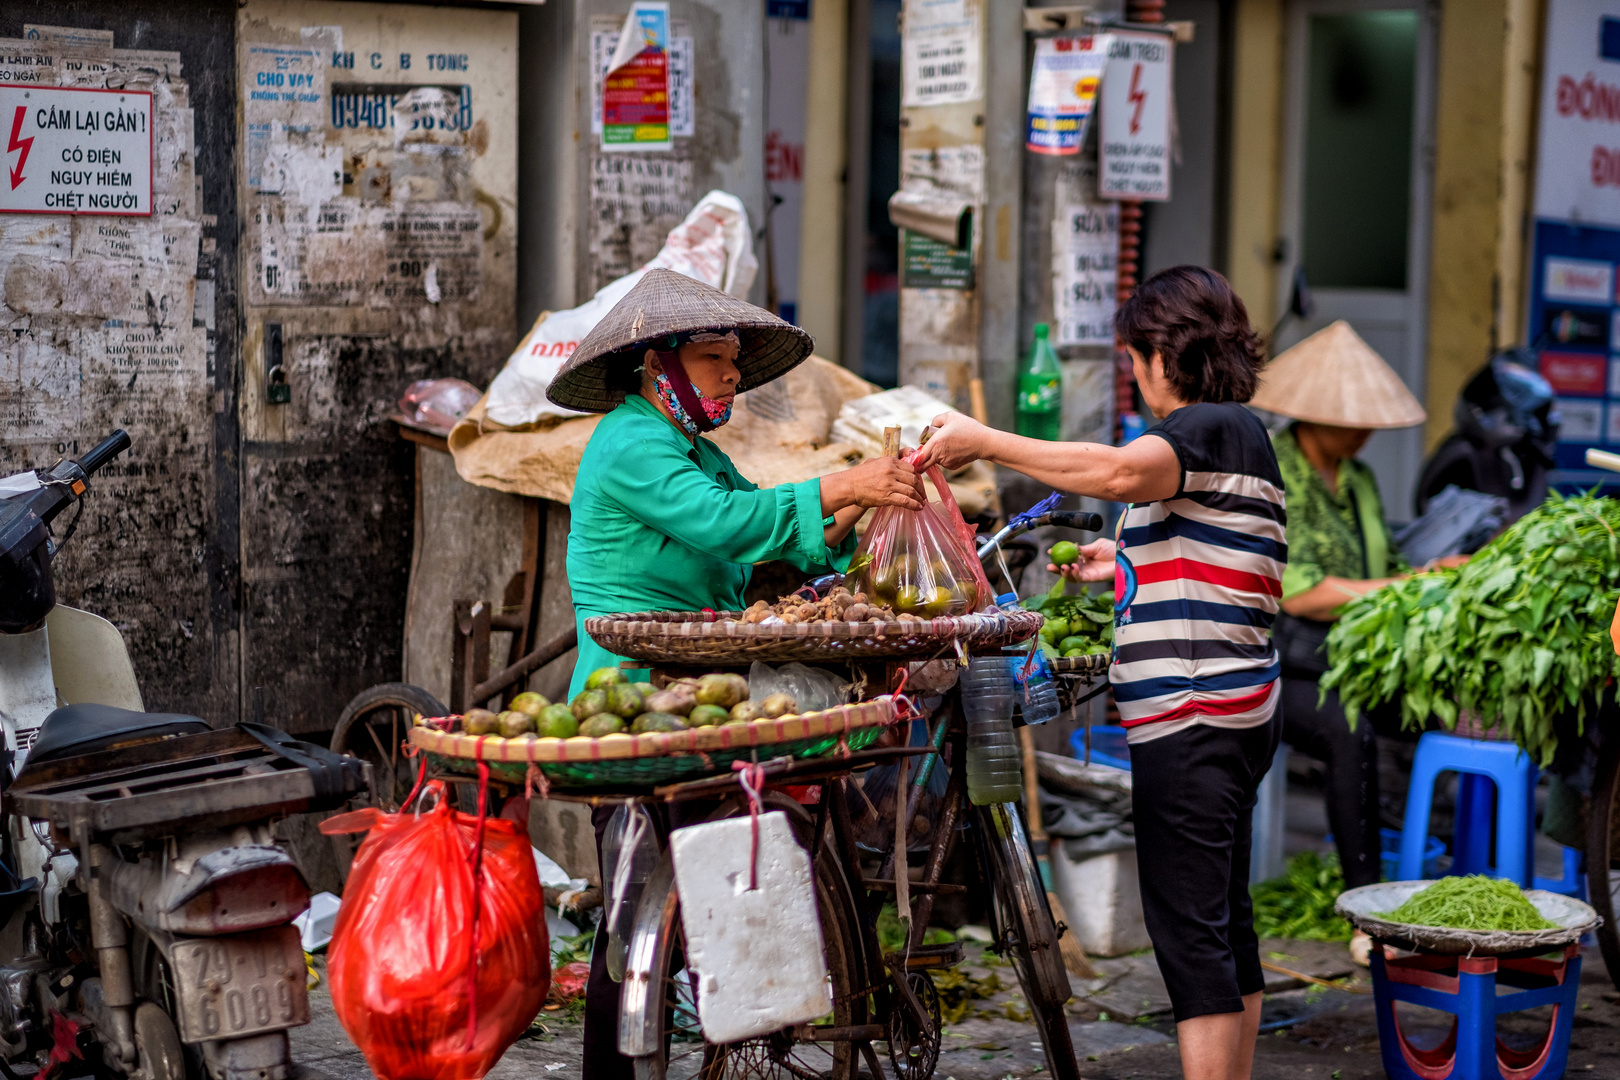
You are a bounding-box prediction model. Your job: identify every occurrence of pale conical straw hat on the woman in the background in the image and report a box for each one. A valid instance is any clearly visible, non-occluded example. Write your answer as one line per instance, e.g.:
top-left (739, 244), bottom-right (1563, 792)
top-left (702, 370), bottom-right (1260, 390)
top-left (1249, 319), bottom-right (1427, 427)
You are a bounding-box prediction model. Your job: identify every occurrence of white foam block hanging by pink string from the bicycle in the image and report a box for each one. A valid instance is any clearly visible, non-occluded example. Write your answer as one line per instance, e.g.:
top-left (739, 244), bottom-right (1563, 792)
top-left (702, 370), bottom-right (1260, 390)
top-left (669, 811), bottom-right (833, 1043)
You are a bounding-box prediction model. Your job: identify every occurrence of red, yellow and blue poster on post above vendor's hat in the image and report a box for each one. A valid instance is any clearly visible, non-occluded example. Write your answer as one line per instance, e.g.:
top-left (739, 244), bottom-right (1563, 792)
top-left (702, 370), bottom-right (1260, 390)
top-left (601, 0), bottom-right (674, 151)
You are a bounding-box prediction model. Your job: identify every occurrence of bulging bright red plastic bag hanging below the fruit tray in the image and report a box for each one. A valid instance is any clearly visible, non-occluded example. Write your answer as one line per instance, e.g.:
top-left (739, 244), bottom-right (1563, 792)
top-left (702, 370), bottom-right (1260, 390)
top-left (321, 780), bottom-right (551, 1080)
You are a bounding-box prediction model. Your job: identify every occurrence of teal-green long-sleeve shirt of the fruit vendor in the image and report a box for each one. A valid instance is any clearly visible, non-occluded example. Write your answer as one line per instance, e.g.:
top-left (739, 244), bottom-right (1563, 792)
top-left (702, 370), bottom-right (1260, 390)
top-left (569, 397), bottom-right (855, 698)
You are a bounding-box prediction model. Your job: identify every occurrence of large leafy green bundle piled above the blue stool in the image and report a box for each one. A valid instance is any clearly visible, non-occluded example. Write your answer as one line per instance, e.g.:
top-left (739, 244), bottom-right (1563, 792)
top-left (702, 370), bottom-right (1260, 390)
top-left (1322, 494), bottom-right (1620, 764)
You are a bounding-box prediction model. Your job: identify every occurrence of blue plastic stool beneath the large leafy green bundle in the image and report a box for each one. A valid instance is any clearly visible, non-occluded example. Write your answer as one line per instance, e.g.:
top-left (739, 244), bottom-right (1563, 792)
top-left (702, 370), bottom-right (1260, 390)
top-left (1398, 732), bottom-right (1539, 889)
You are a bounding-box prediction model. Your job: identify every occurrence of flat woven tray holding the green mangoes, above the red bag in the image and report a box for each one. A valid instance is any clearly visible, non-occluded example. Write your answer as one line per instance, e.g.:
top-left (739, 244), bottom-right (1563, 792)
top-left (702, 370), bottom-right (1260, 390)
top-left (410, 695), bottom-right (896, 789)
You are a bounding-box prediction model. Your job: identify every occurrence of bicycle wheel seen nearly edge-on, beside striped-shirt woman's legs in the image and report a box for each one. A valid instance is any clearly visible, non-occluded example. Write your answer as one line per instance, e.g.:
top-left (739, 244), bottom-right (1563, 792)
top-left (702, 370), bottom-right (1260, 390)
top-left (974, 803), bottom-right (1081, 1080)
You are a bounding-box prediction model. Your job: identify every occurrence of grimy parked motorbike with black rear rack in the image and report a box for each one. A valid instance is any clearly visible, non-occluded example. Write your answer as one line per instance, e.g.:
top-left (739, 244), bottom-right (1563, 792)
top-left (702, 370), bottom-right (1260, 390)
top-left (0, 431), bottom-right (371, 1080)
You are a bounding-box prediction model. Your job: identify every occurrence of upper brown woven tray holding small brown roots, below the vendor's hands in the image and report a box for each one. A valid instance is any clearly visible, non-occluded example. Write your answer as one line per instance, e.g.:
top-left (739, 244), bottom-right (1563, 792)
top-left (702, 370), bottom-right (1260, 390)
top-left (585, 612), bottom-right (1042, 665)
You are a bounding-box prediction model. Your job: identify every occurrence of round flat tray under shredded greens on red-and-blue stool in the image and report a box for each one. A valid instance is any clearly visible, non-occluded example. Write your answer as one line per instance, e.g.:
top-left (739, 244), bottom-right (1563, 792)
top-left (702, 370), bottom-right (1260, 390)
top-left (1333, 881), bottom-right (1602, 957)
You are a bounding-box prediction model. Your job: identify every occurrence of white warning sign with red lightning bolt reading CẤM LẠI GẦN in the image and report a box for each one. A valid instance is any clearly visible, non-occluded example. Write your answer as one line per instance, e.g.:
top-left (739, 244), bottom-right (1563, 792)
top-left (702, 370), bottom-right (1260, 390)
top-left (0, 86), bottom-right (152, 217)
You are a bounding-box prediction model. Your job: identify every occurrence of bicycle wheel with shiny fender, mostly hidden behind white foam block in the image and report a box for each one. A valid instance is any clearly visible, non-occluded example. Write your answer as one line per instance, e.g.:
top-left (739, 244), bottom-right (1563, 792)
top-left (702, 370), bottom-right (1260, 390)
top-left (619, 797), bottom-right (867, 1080)
